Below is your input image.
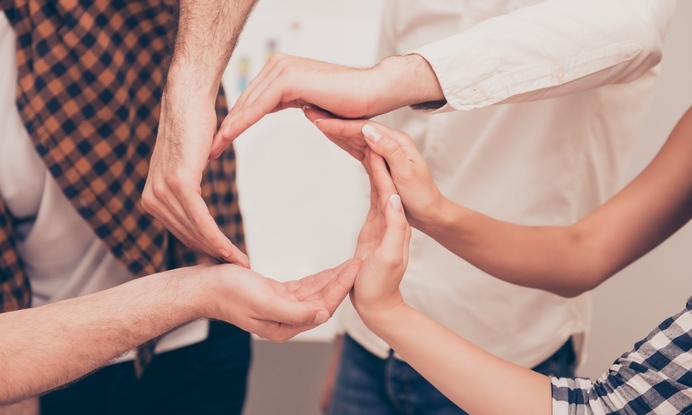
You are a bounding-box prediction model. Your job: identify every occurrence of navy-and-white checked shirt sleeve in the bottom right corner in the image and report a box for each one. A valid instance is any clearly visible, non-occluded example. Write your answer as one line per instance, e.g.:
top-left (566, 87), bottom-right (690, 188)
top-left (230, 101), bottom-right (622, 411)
top-left (551, 298), bottom-right (692, 415)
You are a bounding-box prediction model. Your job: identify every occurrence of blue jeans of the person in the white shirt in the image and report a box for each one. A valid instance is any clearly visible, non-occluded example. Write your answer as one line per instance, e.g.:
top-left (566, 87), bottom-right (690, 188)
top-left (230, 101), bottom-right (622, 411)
top-left (329, 335), bottom-right (576, 415)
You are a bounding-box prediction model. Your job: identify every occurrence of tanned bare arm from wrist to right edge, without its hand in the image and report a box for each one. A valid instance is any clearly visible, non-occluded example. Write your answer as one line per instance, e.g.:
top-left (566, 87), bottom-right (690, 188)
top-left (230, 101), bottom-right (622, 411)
top-left (416, 105), bottom-right (692, 296)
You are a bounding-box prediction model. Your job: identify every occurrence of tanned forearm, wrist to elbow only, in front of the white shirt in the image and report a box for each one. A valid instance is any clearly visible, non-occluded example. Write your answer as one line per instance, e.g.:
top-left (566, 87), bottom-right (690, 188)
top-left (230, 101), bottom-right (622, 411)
top-left (417, 199), bottom-right (602, 297)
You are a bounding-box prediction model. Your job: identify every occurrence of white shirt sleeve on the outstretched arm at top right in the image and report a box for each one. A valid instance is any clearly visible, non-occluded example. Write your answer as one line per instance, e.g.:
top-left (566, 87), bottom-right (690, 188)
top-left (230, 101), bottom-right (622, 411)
top-left (411, 0), bottom-right (677, 110)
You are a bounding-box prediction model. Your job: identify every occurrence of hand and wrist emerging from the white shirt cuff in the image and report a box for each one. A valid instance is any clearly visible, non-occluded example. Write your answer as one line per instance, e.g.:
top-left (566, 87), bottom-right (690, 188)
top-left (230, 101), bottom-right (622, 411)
top-left (211, 54), bottom-right (444, 158)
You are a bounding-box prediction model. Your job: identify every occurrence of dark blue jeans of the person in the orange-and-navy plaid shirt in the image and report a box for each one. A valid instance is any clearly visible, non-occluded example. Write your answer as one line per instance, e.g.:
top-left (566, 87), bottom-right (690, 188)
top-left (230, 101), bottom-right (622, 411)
top-left (41, 321), bottom-right (252, 415)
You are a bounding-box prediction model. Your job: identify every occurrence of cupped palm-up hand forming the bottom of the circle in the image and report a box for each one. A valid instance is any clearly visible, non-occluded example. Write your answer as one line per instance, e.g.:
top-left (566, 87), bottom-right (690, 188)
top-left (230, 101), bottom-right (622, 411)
top-left (203, 259), bottom-right (361, 342)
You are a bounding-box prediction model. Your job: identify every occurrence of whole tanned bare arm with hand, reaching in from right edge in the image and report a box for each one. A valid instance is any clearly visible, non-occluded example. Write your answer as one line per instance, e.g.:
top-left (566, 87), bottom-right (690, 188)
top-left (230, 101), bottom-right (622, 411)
top-left (306, 105), bottom-right (692, 297)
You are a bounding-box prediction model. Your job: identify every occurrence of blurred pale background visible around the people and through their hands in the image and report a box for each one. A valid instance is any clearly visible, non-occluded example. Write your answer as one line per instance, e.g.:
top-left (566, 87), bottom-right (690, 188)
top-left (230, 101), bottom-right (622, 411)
top-left (224, 0), bottom-right (692, 415)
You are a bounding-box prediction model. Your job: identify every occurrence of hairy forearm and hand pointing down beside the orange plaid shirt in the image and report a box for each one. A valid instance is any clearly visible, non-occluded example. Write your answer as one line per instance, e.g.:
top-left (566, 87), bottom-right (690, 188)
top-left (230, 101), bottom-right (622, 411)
top-left (142, 0), bottom-right (257, 267)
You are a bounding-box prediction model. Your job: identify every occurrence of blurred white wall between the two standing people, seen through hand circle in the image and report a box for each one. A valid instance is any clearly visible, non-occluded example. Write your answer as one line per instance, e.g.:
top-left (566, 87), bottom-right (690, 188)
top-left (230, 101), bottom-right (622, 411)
top-left (224, 0), bottom-right (381, 340)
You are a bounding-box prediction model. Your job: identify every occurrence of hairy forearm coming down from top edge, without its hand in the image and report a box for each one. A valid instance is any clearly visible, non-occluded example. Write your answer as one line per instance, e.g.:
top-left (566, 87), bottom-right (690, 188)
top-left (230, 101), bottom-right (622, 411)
top-left (167, 0), bottom-right (257, 100)
